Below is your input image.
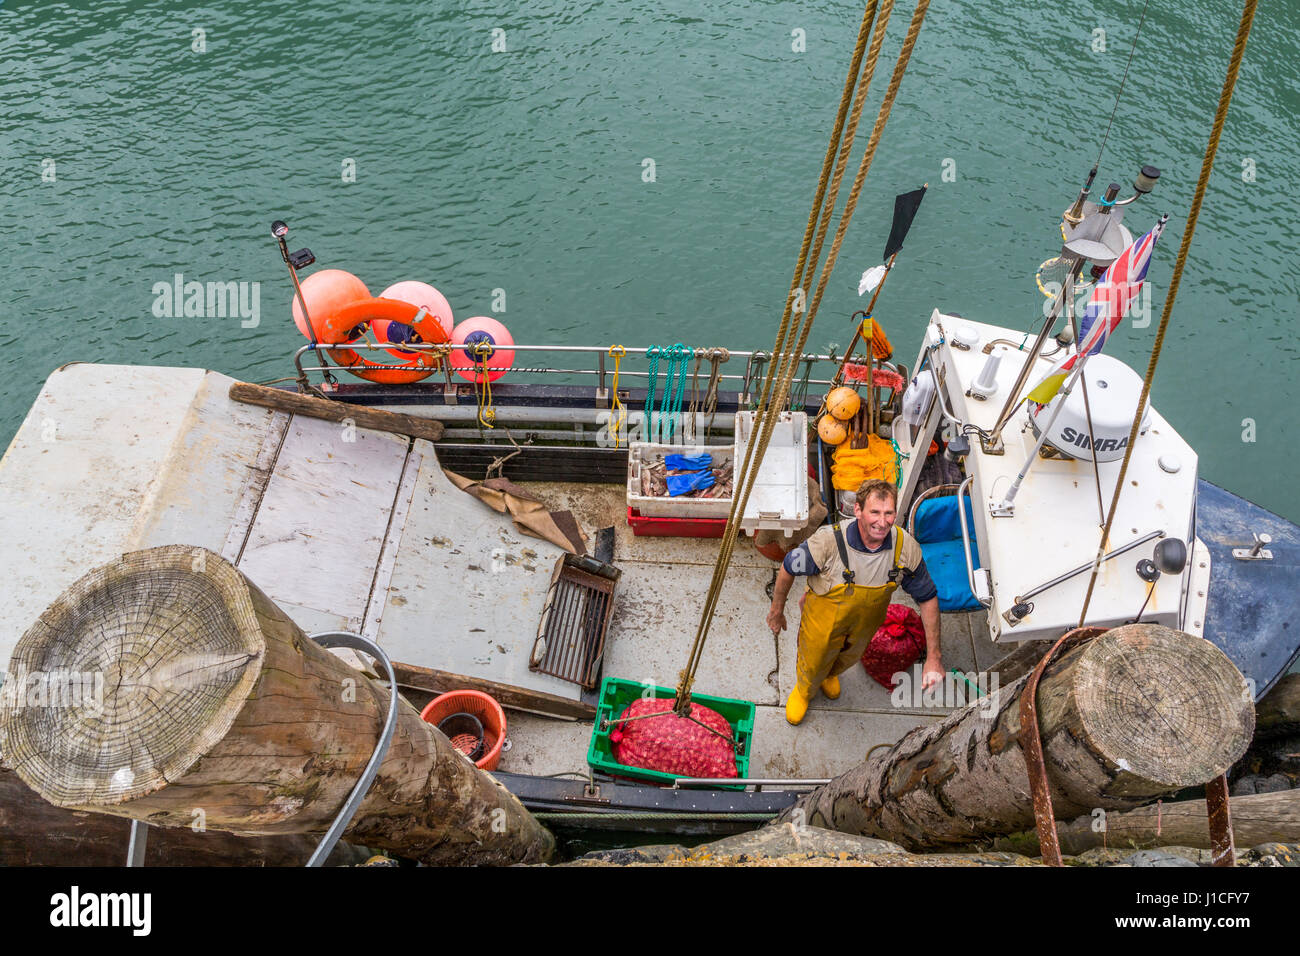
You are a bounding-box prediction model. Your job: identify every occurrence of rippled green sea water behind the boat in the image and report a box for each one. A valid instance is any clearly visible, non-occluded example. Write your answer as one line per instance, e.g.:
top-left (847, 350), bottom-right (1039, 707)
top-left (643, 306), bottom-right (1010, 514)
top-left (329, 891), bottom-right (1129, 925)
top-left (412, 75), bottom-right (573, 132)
top-left (0, 0), bottom-right (1300, 519)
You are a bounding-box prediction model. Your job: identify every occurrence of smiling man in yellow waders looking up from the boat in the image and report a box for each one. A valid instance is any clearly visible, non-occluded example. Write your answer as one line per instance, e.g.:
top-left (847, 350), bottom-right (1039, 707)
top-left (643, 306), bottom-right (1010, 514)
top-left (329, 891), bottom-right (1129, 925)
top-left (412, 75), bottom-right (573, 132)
top-left (767, 480), bottom-right (944, 723)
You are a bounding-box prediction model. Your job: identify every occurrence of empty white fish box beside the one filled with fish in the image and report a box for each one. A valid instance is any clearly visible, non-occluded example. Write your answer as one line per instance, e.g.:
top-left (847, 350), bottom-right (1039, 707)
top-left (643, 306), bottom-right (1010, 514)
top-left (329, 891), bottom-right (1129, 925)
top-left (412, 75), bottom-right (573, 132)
top-left (736, 411), bottom-right (809, 537)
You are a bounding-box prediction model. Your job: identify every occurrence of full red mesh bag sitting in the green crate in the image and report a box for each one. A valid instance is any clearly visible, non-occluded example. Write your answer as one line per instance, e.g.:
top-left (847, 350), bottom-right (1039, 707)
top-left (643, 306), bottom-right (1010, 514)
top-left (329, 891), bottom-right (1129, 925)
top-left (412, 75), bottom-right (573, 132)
top-left (610, 698), bottom-right (738, 777)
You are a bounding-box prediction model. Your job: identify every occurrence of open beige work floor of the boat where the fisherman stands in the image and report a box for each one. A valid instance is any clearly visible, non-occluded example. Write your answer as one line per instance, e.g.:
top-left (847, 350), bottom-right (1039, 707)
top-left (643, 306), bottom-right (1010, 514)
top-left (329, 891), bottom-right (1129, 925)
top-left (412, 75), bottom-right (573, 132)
top-left (501, 483), bottom-right (1008, 779)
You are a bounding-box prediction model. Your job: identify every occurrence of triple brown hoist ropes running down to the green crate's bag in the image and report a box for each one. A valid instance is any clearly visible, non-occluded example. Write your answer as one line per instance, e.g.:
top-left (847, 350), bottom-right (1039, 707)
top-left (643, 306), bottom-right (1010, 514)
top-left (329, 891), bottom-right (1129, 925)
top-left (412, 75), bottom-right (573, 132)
top-left (677, 0), bottom-right (930, 713)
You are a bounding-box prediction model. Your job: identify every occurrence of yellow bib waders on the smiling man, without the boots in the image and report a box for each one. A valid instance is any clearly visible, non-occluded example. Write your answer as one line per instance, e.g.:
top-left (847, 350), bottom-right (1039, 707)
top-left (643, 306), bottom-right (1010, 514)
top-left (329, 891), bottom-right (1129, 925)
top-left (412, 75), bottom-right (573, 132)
top-left (794, 533), bottom-right (902, 701)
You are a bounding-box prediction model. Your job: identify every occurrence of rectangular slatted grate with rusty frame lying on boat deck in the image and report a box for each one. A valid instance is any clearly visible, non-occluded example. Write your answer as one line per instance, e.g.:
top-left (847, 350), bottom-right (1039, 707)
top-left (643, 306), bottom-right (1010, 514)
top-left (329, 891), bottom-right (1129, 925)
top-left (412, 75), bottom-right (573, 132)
top-left (528, 554), bottom-right (621, 691)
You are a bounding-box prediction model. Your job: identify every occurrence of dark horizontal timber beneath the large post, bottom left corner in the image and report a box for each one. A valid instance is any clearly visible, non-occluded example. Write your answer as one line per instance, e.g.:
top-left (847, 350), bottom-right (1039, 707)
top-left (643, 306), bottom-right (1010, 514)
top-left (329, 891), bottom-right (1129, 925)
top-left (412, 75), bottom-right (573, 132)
top-left (0, 770), bottom-right (371, 866)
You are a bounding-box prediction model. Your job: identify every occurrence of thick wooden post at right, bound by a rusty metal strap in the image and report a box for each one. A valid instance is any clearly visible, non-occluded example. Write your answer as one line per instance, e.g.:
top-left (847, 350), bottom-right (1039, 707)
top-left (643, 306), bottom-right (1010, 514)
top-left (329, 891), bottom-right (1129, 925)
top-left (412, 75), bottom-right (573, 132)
top-left (781, 624), bottom-right (1255, 849)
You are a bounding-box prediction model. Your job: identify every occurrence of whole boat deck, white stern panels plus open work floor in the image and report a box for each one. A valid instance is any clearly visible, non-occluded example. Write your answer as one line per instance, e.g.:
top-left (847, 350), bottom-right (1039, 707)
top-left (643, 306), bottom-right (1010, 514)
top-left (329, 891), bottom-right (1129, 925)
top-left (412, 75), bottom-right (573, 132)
top-left (0, 364), bottom-right (1002, 778)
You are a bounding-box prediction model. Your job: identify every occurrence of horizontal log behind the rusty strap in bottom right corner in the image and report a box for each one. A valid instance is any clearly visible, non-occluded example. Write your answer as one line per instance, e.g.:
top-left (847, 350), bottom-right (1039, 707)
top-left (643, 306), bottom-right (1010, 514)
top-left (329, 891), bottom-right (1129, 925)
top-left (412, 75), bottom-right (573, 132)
top-left (993, 790), bottom-right (1300, 856)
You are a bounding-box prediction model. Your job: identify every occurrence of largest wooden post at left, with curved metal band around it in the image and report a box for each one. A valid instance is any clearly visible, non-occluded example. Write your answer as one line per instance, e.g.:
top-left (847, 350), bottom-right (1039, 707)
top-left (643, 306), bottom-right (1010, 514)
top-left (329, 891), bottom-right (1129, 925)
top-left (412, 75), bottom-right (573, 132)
top-left (0, 545), bottom-right (554, 864)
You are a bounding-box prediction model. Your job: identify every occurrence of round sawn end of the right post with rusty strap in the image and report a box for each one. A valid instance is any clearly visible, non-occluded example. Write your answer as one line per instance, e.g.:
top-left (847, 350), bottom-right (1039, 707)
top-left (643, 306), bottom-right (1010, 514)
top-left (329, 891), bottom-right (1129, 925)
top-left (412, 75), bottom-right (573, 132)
top-left (1074, 624), bottom-right (1255, 790)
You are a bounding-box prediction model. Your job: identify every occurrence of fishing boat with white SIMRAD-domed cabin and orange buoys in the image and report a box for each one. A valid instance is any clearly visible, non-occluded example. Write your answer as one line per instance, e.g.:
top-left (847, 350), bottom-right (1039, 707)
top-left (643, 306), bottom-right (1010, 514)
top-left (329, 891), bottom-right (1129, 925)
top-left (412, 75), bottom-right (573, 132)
top-left (0, 0), bottom-right (1300, 863)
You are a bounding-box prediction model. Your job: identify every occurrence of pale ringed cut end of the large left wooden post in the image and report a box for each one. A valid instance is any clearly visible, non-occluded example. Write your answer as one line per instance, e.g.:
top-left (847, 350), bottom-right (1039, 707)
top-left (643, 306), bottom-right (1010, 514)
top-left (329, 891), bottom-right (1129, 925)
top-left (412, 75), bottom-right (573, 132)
top-left (0, 545), bottom-right (265, 806)
